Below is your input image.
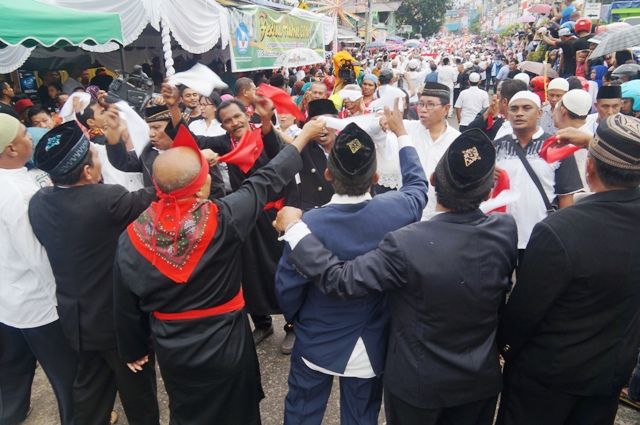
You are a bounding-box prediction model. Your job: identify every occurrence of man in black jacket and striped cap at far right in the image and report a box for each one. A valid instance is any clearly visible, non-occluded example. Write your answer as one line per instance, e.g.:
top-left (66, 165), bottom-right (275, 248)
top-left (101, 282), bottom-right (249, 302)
top-left (498, 115), bottom-right (640, 425)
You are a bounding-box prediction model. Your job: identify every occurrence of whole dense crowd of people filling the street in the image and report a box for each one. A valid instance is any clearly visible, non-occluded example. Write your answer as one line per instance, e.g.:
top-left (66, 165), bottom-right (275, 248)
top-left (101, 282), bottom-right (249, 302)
top-left (0, 12), bottom-right (640, 425)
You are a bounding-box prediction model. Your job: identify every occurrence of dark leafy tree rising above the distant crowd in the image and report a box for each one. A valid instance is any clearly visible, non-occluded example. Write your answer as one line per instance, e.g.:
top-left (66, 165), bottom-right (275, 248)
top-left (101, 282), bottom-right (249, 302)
top-left (396, 0), bottom-right (449, 37)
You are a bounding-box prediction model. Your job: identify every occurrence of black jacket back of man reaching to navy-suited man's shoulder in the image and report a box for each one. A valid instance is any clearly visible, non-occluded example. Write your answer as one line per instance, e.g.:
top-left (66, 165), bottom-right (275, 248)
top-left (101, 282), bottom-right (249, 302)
top-left (385, 210), bottom-right (517, 408)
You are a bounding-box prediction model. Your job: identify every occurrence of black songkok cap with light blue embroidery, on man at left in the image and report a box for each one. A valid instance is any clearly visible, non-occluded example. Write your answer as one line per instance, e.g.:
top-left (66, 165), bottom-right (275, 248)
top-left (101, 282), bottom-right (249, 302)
top-left (33, 121), bottom-right (89, 177)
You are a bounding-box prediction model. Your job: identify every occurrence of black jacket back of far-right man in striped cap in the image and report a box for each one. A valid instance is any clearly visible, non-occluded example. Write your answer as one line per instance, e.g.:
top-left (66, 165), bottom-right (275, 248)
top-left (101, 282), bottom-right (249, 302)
top-left (500, 189), bottom-right (640, 396)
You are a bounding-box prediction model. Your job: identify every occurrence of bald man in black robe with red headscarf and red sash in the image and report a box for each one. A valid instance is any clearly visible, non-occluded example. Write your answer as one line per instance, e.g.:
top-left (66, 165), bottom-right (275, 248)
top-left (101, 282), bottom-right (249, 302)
top-left (114, 110), bottom-right (325, 425)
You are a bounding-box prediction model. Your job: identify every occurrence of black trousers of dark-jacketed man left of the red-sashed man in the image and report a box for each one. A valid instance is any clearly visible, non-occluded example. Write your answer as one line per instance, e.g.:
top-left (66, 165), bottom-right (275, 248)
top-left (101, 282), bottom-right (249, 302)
top-left (74, 349), bottom-right (160, 425)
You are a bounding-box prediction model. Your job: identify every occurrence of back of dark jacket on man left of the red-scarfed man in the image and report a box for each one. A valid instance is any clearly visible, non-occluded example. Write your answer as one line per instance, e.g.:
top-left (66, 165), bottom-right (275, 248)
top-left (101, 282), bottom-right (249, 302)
top-left (29, 184), bottom-right (155, 350)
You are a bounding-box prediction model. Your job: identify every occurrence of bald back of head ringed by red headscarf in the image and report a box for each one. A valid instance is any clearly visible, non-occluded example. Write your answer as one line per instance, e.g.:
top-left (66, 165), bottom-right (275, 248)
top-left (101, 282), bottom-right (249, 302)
top-left (153, 146), bottom-right (200, 193)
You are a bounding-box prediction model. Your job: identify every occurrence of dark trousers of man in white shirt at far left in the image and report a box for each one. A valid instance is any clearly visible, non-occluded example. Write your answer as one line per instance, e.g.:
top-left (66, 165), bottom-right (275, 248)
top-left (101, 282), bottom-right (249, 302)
top-left (0, 320), bottom-right (76, 425)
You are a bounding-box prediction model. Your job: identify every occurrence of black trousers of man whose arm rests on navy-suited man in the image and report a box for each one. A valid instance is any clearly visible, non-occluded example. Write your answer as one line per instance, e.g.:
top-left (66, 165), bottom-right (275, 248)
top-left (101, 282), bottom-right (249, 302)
top-left (384, 388), bottom-right (498, 425)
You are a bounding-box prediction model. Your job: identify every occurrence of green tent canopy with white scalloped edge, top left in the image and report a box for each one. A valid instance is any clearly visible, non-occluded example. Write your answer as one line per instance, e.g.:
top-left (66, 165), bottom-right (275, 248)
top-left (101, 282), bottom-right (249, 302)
top-left (0, 0), bottom-right (123, 47)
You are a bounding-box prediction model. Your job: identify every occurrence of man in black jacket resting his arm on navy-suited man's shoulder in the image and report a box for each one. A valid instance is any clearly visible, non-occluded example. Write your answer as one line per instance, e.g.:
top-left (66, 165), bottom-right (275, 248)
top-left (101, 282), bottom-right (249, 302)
top-left (276, 130), bottom-right (517, 425)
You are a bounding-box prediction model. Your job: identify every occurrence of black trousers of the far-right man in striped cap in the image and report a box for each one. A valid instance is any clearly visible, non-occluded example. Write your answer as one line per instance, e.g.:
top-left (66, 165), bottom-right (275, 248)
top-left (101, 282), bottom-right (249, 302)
top-left (496, 366), bottom-right (620, 425)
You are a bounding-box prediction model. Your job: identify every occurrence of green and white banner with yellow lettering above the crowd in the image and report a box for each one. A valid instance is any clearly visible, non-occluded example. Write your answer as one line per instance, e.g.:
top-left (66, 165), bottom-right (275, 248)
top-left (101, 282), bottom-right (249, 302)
top-left (229, 6), bottom-right (324, 72)
